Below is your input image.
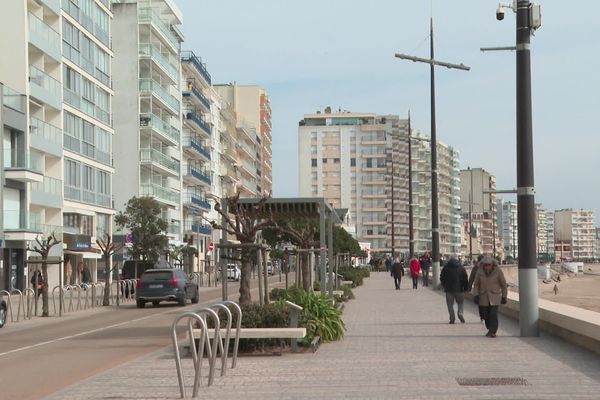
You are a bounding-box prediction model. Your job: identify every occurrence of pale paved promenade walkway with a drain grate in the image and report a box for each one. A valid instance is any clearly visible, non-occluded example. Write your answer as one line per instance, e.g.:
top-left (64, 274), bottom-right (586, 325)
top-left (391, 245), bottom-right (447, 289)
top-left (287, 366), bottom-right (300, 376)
top-left (48, 273), bottom-right (600, 400)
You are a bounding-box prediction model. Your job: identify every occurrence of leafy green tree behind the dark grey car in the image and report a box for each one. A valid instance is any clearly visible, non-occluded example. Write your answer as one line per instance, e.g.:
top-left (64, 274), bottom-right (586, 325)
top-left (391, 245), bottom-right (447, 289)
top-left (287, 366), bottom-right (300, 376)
top-left (115, 197), bottom-right (169, 261)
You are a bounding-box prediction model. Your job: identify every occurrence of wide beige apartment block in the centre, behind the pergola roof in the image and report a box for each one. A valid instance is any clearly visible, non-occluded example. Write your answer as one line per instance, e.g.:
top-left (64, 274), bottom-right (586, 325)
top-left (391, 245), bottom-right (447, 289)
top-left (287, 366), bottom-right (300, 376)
top-left (298, 108), bottom-right (409, 253)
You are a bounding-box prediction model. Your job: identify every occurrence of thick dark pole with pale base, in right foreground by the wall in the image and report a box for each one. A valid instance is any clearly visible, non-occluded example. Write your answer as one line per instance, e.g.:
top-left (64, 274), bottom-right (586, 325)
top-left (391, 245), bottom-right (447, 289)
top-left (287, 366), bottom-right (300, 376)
top-left (516, 0), bottom-right (539, 336)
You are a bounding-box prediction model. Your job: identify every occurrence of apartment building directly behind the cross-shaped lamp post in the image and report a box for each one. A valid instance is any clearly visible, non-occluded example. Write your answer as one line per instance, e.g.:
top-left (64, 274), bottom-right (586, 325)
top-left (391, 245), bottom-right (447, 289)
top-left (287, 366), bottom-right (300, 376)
top-left (412, 135), bottom-right (462, 257)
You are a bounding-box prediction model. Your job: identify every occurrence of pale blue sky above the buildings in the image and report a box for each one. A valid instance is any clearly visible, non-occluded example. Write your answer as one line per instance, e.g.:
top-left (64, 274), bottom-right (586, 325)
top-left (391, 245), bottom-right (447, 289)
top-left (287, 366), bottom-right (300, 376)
top-left (177, 0), bottom-right (600, 225)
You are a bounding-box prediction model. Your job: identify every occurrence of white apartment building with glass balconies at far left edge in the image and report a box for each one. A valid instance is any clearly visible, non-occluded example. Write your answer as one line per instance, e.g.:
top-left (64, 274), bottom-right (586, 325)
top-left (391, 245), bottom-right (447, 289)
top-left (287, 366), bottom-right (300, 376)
top-left (0, 0), bottom-right (114, 289)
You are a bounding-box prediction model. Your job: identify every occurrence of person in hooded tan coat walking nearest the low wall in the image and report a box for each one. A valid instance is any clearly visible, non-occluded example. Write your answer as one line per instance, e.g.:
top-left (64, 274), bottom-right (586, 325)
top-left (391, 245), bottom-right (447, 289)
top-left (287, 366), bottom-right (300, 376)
top-left (473, 255), bottom-right (508, 338)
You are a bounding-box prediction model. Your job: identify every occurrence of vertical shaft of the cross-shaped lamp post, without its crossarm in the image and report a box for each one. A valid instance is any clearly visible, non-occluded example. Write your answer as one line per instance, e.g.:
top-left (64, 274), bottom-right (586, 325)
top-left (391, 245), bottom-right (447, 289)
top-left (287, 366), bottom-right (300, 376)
top-left (429, 18), bottom-right (440, 288)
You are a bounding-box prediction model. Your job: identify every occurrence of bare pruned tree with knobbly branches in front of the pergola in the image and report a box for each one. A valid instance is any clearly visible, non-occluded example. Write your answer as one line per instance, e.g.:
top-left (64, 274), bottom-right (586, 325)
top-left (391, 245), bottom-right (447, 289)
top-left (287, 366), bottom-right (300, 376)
top-left (211, 192), bottom-right (275, 305)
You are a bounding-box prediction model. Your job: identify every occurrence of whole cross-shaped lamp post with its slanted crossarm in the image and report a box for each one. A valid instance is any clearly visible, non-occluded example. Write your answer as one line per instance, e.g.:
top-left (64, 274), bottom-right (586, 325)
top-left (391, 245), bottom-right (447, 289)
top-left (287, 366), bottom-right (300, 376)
top-left (395, 18), bottom-right (471, 288)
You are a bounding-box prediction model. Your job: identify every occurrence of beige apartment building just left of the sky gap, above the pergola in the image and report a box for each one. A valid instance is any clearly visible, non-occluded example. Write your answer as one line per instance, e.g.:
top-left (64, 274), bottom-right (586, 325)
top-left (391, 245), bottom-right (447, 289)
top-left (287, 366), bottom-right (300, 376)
top-left (214, 83), bottom-right (273, 197)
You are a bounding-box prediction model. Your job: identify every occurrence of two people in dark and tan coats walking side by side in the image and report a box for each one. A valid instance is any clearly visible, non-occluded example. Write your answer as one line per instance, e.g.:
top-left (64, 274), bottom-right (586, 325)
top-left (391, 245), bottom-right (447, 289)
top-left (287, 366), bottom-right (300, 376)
top-left (440, 256), bottom-right (508, 338)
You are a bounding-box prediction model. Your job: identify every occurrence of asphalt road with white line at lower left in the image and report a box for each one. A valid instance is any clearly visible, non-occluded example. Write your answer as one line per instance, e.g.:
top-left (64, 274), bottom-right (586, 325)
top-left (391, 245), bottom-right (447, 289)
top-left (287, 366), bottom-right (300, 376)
top-left (0, 276), bottom-right (282, 400)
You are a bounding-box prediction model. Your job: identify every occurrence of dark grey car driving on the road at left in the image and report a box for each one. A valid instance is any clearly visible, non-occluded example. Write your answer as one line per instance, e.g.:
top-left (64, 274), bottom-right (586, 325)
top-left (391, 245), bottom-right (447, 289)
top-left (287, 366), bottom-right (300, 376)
top-left (135, 268), bottom-right (200, 308)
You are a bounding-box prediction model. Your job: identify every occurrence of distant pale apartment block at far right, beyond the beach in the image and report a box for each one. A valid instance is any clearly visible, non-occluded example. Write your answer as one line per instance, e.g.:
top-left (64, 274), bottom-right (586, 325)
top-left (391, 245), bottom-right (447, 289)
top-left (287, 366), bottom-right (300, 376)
top-left (554, 209), bottom-right (596, 261)
